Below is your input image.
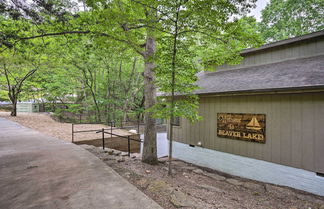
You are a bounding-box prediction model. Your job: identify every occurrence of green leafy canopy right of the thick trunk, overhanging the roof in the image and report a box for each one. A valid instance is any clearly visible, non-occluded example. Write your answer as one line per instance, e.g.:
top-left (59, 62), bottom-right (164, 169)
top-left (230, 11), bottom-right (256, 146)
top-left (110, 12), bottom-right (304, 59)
top-left (151, 0), bottom-right (262, 122)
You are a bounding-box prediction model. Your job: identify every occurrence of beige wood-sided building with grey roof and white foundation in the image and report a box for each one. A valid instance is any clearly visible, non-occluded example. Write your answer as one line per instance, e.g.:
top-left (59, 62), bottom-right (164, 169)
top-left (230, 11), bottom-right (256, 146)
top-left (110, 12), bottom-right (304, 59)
top-left (167, 31), bottom-right (324, 195)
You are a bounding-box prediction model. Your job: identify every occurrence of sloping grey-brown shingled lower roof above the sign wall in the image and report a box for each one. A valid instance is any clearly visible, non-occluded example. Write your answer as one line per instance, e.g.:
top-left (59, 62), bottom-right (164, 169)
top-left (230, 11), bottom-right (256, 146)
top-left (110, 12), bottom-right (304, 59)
top-left (195, 55), bottom-right (324, 94)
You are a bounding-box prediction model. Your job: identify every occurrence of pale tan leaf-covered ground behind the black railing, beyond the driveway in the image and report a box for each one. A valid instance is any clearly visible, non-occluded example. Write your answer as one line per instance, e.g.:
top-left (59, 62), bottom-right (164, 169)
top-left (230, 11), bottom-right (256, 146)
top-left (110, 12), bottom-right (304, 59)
top-left (0, 112), bottom-right (135, 141)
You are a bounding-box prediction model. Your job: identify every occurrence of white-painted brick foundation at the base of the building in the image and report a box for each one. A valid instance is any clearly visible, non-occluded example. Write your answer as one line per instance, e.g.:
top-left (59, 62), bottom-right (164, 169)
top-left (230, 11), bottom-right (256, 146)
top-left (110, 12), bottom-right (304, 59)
top-left (173, 142), bottom-right (324, 196)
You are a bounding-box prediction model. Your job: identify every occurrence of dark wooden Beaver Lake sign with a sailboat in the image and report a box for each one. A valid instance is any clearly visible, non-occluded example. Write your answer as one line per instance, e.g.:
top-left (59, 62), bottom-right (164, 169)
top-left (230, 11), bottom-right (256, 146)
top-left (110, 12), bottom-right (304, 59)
top-left (217, 113), bottom-right (266, 143)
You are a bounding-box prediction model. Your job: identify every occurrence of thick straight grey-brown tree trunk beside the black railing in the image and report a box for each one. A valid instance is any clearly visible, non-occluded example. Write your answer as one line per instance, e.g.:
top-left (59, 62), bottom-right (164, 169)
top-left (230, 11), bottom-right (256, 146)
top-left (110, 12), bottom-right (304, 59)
top-left (142, 36), bottom-right (158, 164)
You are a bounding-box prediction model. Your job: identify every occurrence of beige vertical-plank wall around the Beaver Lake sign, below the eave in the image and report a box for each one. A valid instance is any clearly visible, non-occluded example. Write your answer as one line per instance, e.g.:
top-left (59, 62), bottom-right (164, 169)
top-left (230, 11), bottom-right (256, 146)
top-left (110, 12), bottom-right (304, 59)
top-left (168, 92), bottom-right (324, 173)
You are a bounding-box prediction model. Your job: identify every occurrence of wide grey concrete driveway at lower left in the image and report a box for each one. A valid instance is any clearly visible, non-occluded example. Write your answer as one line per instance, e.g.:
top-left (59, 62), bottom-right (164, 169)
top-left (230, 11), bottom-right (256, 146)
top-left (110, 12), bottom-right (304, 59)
top-left (0, 118), bottom-right (161, 209)
